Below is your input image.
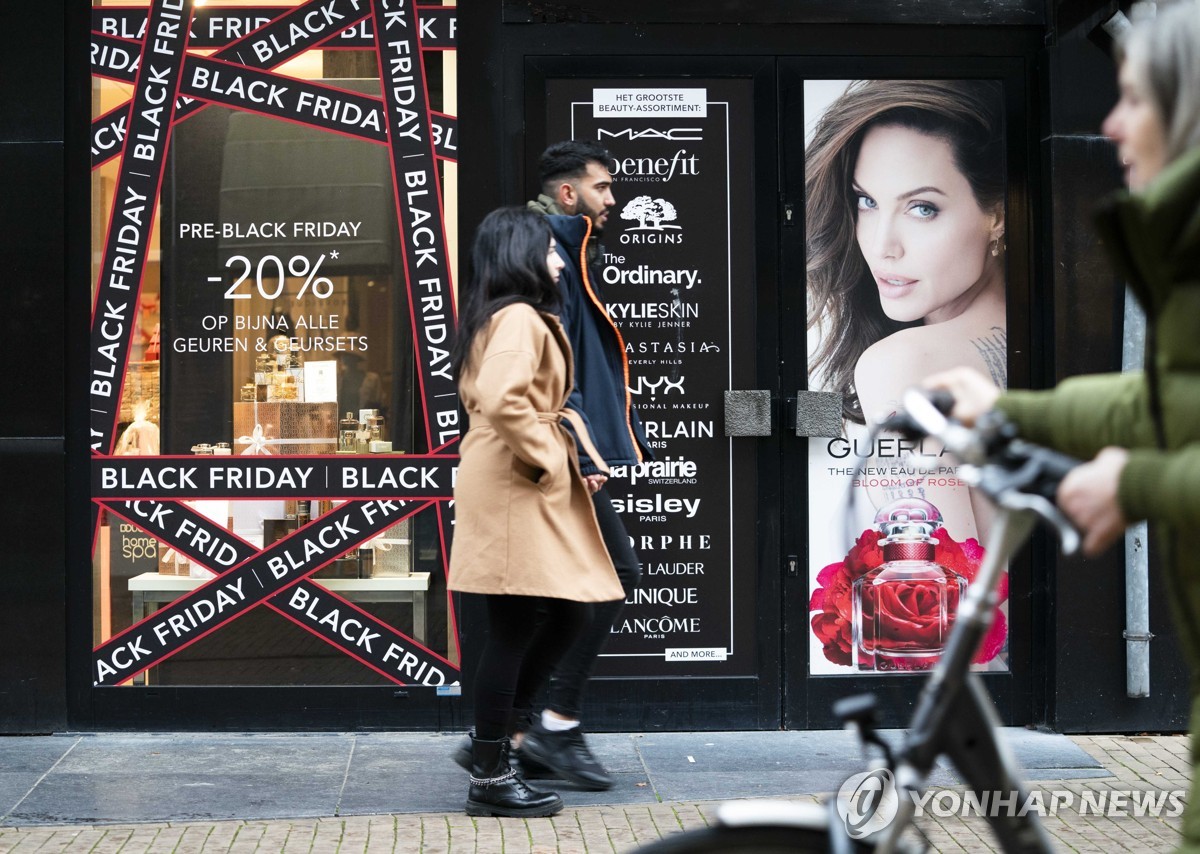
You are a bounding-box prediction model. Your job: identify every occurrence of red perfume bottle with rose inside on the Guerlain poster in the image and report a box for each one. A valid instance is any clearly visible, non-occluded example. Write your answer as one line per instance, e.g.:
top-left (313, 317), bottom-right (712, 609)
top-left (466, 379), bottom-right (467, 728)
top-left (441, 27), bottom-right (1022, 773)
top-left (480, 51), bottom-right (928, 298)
top-left (851, 498), bottom-right (966, 672)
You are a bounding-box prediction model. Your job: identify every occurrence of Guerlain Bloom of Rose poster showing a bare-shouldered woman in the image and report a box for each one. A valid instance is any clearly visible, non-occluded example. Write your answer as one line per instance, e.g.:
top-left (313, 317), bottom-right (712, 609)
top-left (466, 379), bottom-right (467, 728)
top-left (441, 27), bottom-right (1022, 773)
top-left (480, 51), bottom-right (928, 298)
top-left (804, 79), bottom-right (1008, 674)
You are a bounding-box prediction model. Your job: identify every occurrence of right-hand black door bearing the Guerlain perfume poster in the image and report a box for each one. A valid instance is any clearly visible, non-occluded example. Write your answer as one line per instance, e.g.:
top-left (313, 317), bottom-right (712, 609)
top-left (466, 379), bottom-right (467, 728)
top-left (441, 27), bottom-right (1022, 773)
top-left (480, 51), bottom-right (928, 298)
top-left (779, 58), bottom-right (1033, 729)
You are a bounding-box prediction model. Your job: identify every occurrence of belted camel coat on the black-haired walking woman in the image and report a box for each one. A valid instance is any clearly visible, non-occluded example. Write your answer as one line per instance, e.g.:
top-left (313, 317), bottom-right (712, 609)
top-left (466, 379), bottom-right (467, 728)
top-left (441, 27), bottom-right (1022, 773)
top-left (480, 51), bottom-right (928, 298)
top-left (449, 302), bottom-right (624, 602)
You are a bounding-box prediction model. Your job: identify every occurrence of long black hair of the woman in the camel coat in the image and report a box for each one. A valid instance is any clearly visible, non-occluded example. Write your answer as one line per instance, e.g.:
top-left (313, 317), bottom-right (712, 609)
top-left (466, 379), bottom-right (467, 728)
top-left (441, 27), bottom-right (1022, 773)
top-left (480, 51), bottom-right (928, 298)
top-left (450, 208), bottom-right (562, 377)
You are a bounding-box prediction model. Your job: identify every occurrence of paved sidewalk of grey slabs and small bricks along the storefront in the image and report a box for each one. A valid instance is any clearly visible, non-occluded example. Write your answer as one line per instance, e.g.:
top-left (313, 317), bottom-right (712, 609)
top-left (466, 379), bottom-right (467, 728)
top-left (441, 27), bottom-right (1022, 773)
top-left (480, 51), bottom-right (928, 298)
top-left (0, 729), bottom-right (1189, 854)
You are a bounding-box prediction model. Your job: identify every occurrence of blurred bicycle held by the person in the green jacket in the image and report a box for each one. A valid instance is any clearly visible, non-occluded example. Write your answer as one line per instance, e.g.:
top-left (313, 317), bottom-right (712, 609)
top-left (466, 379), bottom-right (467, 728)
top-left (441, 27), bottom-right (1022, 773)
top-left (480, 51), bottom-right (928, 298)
top-left (637, 389), bottom-right (1080, 854)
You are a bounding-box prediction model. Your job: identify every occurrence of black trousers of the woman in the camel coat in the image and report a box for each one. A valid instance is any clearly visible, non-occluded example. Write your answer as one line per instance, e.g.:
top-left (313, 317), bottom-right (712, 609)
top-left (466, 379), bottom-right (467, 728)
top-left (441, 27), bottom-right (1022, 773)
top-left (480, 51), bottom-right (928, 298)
top-left (475, 595), bottom-right (587, 740)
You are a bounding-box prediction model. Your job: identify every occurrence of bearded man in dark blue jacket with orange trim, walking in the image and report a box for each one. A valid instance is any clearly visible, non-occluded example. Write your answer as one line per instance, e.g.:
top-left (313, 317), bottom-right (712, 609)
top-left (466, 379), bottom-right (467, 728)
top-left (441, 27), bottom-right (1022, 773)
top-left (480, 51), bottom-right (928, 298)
top-left (517, 142), bottom-right (653, 789)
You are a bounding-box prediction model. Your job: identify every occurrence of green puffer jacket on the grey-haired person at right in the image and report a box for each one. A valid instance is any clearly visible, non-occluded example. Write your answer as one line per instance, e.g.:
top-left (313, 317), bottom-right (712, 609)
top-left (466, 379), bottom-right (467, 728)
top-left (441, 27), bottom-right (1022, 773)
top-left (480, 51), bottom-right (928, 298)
top-left (996, 149), bottom-right (1200, 671)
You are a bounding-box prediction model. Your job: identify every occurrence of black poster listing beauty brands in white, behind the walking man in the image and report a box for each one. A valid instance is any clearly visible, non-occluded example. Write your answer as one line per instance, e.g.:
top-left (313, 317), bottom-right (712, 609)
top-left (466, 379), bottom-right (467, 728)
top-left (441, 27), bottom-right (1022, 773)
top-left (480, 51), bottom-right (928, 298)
top-left (546, 79), bottom-right (757, 676)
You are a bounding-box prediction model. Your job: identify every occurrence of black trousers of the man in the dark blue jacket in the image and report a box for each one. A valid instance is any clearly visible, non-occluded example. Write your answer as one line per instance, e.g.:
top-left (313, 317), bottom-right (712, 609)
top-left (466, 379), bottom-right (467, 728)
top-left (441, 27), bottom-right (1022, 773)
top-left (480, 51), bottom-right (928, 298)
top-left (514, 489), bottom-right (642, 730)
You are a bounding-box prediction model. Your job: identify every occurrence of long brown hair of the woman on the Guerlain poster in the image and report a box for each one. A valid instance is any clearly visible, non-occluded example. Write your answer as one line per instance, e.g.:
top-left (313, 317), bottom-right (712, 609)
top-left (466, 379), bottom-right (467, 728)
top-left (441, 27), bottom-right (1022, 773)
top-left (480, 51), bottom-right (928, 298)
top-left (804, 80), bottom-right (1006, 423)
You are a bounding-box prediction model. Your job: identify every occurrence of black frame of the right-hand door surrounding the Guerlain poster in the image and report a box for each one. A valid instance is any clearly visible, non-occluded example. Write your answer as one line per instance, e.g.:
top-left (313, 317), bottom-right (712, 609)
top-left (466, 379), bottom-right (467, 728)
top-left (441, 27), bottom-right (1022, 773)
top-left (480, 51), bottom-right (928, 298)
top-left (779, 55), bottom-right (1044, 729)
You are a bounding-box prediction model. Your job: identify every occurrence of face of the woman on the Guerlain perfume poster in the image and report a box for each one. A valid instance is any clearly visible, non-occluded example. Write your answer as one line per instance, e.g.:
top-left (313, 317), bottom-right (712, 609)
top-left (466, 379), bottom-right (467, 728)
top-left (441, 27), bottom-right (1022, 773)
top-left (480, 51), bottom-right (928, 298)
top-left (853, 126), bottom-right (1003, 323)
